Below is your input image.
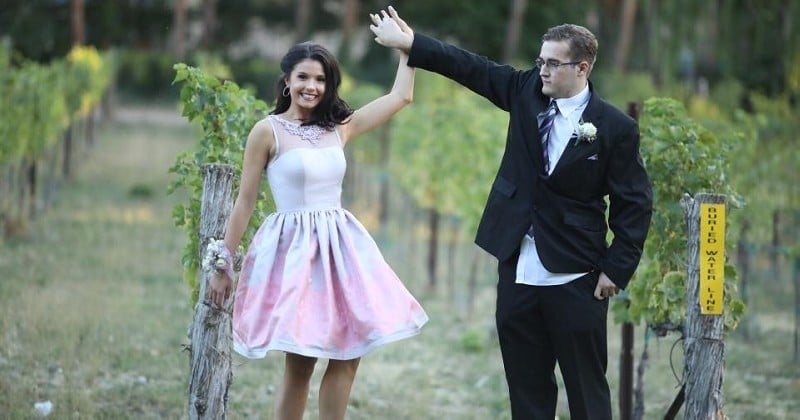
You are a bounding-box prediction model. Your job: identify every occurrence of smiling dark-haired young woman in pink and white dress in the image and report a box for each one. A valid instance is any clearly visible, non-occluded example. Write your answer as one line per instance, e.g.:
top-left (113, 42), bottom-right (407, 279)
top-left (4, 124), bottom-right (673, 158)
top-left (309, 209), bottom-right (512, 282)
top-left (208, 12), bottom-right (428, 419)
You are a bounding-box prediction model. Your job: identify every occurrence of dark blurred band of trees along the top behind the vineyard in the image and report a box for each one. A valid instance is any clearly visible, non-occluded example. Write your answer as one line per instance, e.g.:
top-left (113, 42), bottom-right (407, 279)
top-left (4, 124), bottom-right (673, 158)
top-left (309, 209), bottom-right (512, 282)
top-left (0, 0), bottom-right (800, 96)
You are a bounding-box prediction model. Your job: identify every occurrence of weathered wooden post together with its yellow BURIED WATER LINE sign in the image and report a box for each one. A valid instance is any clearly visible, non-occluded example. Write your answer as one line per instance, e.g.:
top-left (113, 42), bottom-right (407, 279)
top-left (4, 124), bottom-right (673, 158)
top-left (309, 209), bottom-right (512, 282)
top-left (681, 194), bottom-right (727, 420)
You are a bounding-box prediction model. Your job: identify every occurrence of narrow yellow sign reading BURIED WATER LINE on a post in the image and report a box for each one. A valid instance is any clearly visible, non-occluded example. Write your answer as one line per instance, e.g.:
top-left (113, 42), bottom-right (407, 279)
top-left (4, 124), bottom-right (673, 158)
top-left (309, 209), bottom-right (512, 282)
top-left (698, 203), bottom-right (725, 315)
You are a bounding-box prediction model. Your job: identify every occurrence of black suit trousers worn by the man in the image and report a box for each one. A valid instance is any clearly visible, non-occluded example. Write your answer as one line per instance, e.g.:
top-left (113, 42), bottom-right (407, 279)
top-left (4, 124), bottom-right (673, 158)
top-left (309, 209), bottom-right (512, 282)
top-left (496, 252), bottom-right (611, 420)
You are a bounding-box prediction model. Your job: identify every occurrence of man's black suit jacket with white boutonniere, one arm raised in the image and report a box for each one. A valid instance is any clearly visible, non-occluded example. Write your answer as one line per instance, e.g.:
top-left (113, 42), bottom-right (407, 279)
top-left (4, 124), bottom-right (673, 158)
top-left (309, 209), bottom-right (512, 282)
top-left (408, 33), bottom-right (652, 288)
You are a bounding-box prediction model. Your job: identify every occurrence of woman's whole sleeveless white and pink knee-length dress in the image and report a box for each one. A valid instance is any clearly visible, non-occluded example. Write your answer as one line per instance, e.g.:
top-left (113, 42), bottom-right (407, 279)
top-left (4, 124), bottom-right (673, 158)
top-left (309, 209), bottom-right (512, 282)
top-left (233, 115), bottom-right (428, 360)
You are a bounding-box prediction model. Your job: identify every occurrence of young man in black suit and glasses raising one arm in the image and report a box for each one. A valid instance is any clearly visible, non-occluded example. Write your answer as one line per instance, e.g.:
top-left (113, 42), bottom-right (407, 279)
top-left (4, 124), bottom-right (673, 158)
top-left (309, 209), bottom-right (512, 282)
top-left (376, 8), bottom-right (652, 420)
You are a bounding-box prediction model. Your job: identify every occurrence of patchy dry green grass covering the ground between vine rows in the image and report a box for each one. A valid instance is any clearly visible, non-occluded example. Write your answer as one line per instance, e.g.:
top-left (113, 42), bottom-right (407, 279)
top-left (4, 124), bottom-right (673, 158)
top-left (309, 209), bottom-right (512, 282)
top-left (0, 106), bottom-right (800, 420)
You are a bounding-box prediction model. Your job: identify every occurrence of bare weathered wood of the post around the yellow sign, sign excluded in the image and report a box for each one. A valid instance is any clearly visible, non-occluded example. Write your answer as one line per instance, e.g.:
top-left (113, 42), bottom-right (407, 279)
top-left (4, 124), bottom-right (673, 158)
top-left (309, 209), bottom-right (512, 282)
top-left (681, 194), bottom-right (726, 420)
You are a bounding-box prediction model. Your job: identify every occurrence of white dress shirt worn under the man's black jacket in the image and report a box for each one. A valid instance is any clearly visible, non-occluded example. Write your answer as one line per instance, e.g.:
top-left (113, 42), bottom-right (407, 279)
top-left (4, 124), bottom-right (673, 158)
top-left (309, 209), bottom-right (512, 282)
top-left (516, 85), bottom-right (591, 286)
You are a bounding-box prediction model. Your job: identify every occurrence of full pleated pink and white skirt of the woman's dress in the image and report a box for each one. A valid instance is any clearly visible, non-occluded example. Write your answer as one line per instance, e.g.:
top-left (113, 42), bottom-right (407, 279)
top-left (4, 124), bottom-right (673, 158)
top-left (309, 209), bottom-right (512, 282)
top-left (233, 208), bottom-right (428, 360)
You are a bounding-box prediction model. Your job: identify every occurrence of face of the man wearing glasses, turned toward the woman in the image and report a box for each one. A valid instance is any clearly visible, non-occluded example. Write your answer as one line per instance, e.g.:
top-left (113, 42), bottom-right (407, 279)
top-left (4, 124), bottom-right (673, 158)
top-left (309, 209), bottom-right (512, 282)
top-left (537, 41), bottom-right (586, 99)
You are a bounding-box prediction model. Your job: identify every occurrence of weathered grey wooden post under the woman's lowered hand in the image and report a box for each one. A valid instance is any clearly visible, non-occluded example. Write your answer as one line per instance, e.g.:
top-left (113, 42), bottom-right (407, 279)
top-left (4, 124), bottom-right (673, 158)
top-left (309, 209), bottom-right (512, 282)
top-left (188, 164), bottom-right (234, 420)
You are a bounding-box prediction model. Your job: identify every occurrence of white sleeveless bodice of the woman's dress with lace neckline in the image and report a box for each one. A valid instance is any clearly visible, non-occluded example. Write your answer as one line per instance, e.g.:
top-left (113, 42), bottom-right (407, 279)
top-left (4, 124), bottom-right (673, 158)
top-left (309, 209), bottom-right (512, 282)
top-left (267, 115), bottom-right (347, 212)
